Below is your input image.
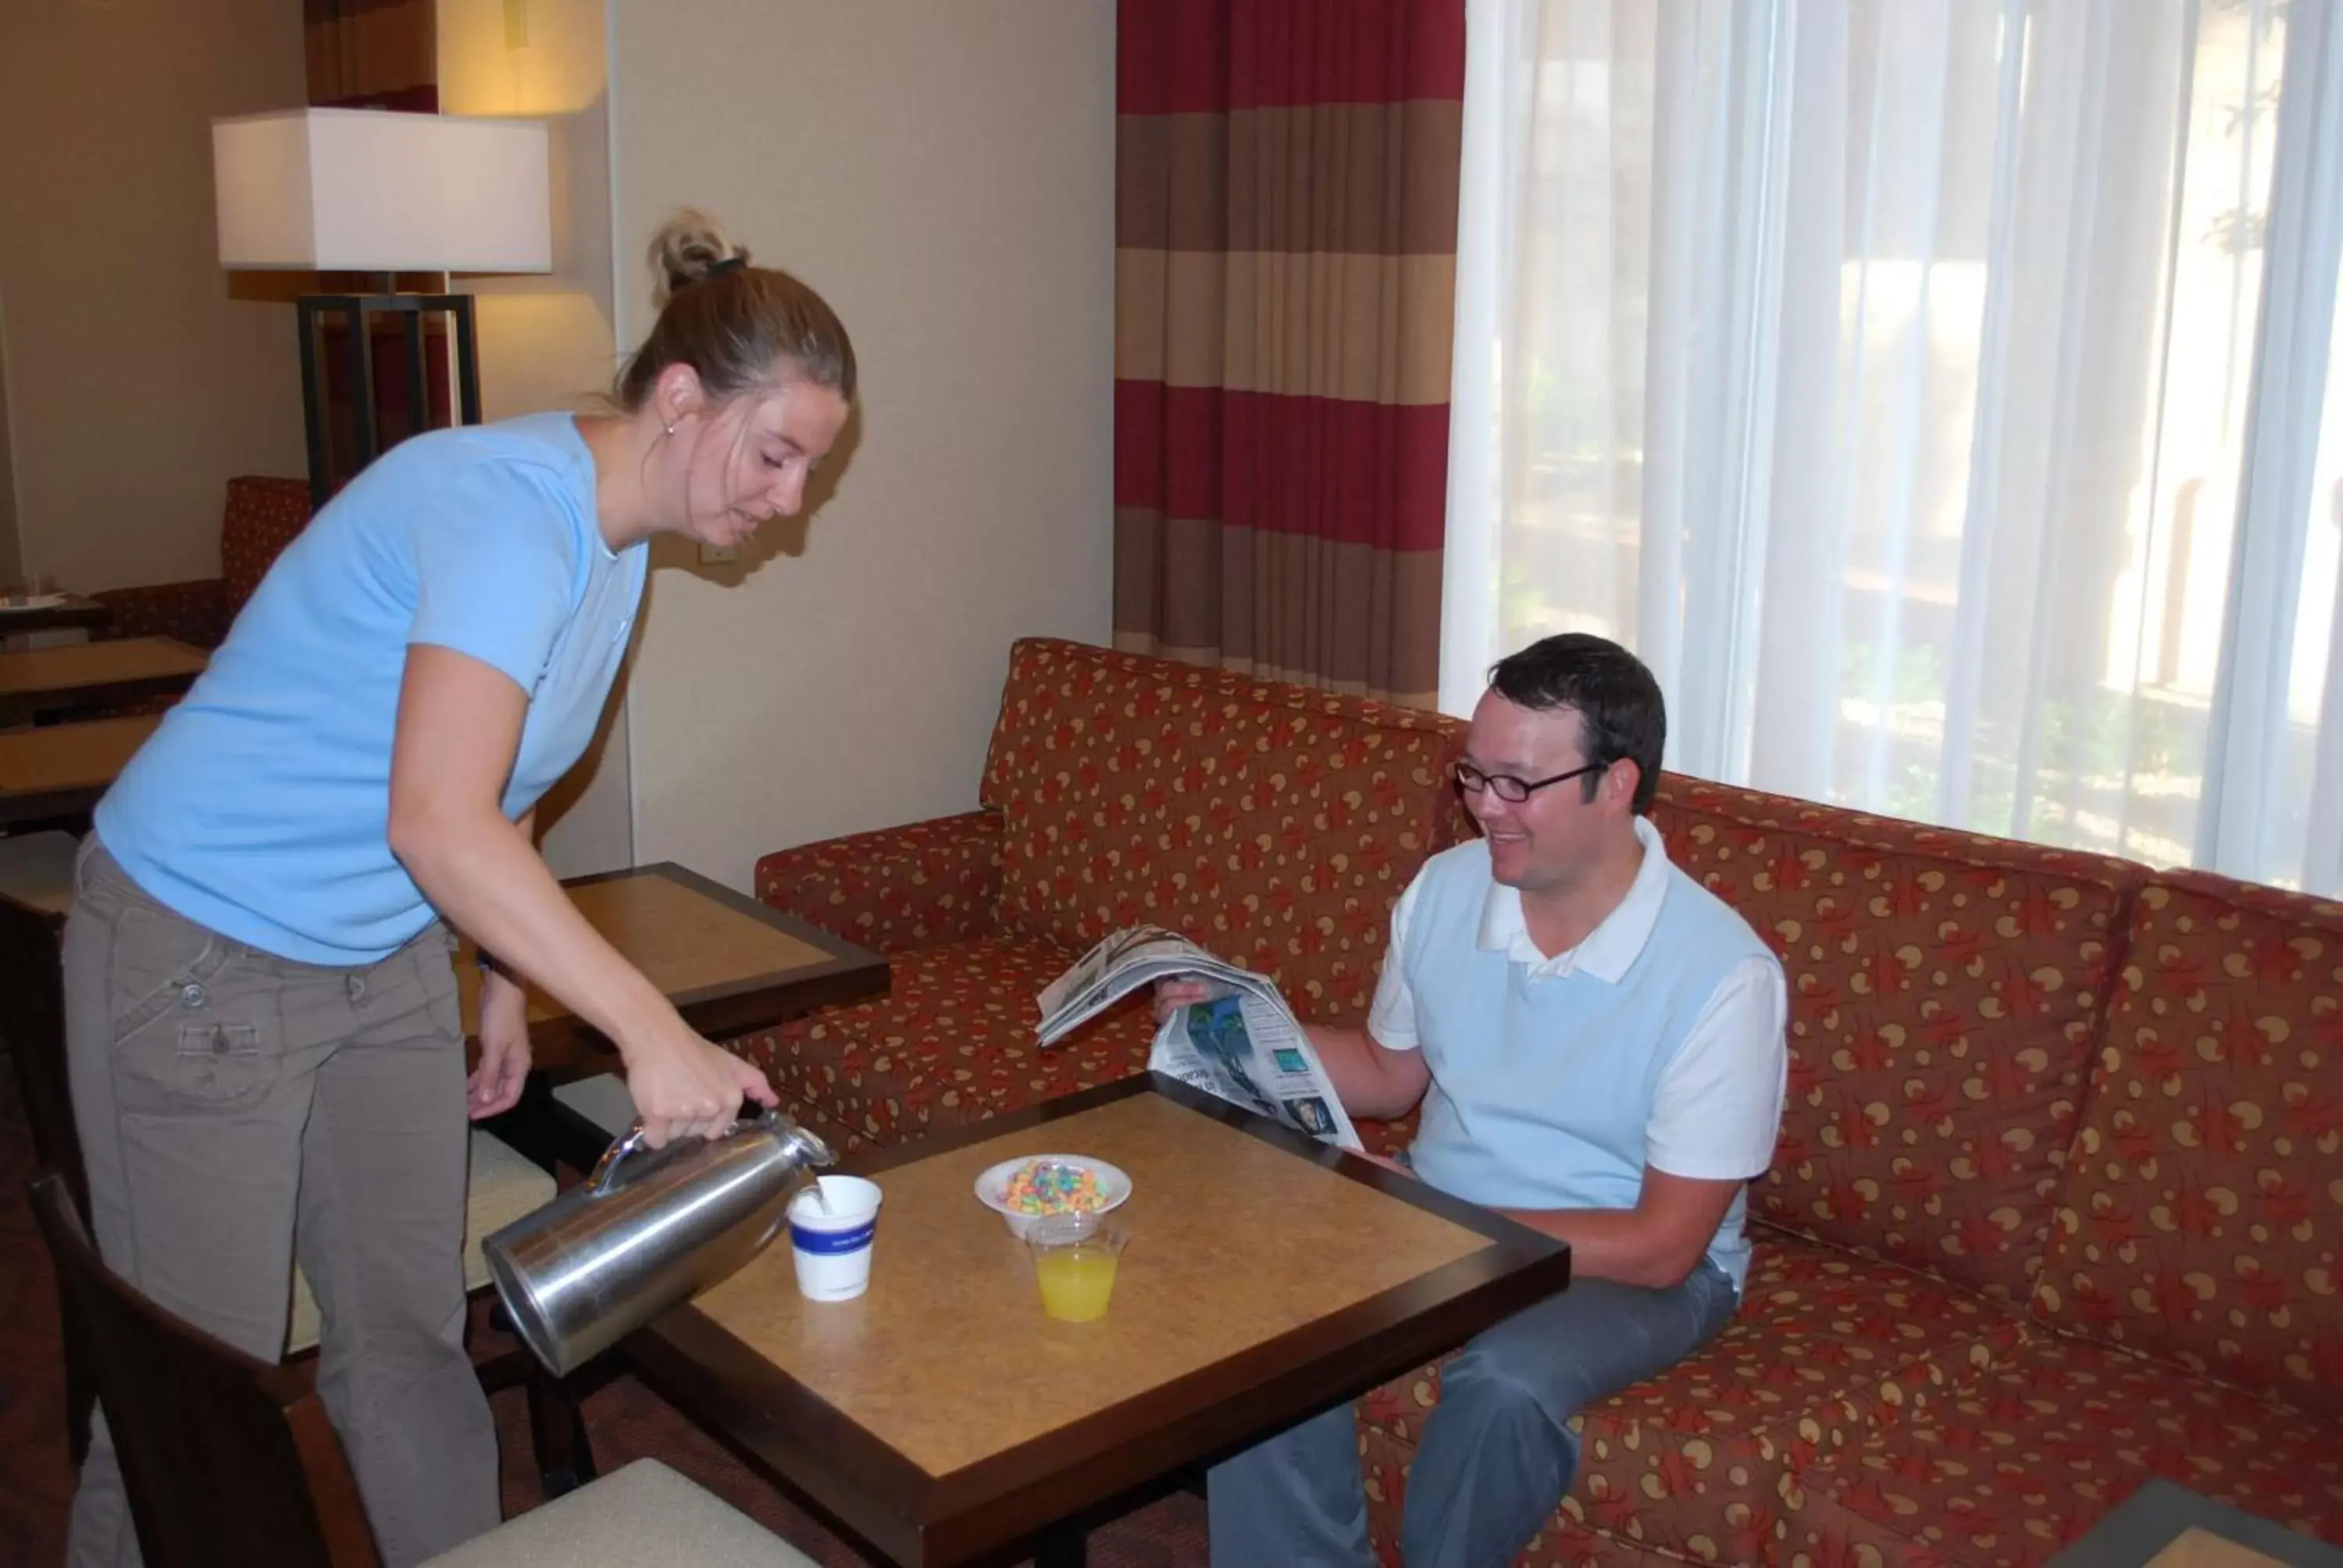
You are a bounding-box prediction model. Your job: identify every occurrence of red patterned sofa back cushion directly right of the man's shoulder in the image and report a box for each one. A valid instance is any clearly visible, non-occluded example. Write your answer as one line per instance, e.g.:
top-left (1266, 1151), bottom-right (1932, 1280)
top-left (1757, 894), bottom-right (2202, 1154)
top-left (1652, 775), bottom-right (2144, 1306)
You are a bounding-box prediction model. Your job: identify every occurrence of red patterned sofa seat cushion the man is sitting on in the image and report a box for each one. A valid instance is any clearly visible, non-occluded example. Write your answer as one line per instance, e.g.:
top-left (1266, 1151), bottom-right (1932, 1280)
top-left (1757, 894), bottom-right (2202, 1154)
top-left (1361, 1231), bottom-right (2024, 1563)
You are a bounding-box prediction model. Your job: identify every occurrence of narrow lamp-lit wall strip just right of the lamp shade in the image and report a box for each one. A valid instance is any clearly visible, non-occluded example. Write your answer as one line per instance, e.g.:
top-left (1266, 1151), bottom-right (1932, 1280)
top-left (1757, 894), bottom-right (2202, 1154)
top-left (438, 0), bottom-right (633, 877)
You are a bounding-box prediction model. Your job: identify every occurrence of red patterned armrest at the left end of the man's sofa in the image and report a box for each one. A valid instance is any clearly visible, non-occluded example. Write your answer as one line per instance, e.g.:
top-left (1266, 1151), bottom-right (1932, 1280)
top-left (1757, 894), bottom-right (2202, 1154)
top-left (757, 811), bottom-right (1000, 957)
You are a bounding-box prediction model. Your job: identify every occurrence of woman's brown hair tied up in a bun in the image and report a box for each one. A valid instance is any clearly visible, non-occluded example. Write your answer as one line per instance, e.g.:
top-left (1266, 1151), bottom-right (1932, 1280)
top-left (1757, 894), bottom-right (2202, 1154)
top-left (614, 208), bottom-right (855, 412)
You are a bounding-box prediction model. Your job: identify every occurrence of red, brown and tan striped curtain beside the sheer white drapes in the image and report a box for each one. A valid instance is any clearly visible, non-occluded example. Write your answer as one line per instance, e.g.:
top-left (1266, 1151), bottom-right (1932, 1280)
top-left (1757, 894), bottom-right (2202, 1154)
top-left (1115, 0), bottom-right (1464, 705)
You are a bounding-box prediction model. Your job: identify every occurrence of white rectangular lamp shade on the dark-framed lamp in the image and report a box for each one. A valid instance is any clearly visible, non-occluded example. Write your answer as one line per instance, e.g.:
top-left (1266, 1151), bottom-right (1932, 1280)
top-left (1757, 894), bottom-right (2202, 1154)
top-left (211, 108), bottom-right (553, 272)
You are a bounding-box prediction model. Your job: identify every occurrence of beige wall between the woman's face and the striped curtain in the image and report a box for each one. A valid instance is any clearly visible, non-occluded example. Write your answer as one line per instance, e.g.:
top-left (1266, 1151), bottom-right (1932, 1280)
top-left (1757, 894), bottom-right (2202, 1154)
top-left (612, 0), bottom-right (1115, 889)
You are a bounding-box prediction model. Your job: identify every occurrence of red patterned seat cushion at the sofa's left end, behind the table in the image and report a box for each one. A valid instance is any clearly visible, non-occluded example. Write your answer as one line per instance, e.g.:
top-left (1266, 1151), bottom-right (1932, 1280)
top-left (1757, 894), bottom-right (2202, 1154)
top-left (733, 938), bottom-right (1155, 1151)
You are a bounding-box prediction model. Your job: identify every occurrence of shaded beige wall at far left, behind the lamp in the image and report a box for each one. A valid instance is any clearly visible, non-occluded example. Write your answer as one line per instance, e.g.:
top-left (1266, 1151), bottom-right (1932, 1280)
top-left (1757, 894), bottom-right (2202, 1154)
top-left (0, 0), bottom-right (307, 588)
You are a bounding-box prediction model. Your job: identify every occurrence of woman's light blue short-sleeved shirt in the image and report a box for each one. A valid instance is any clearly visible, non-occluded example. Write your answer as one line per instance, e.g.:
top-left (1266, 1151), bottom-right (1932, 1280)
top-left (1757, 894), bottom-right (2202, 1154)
top-left (96, 415), bottom-right (649, 966)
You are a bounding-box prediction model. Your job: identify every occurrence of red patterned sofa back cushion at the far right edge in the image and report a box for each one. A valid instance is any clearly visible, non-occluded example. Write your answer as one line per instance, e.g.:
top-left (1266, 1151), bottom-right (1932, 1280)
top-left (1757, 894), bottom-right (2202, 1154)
top-left (2041, 872), bottom-right (2343, 1416)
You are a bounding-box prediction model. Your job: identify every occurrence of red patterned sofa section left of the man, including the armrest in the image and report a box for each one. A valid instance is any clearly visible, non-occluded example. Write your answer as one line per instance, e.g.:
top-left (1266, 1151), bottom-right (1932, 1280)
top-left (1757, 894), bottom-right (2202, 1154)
top-left (745, 640), bottom-right (1455, 1146)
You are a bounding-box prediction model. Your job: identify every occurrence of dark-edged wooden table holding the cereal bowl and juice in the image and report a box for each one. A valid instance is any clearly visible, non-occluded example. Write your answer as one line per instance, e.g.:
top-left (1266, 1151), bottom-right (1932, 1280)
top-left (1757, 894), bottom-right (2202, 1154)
top-left (626, 1074), bottom-right (1570, 1568)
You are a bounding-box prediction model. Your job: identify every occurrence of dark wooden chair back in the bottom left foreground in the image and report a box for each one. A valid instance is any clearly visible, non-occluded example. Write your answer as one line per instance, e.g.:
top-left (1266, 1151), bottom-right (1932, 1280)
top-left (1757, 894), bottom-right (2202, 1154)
top-left (33, 1172), bottom-right (380, 1568)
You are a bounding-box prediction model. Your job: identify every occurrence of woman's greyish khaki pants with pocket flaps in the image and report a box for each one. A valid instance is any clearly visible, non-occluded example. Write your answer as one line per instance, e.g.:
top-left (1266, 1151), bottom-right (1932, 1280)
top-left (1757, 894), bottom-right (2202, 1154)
top-left (66, 835), bottom-right (499, 1568)
